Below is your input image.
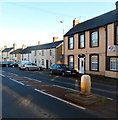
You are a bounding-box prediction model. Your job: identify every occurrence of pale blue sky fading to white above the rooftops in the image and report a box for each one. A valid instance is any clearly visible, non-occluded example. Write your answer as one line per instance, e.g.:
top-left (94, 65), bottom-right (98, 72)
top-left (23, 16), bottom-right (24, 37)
top-left (0, 0), bottom-right (116, 48)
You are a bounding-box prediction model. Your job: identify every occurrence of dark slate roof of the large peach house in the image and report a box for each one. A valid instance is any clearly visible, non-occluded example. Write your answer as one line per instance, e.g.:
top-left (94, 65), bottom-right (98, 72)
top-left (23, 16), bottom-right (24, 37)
top-left (64, 9), bottom-right (118, 36)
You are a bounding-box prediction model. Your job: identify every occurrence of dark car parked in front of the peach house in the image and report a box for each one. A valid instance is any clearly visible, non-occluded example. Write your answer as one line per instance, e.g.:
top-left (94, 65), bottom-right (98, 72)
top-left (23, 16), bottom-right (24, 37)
top-left (49, 64), bottom-right (77, 76)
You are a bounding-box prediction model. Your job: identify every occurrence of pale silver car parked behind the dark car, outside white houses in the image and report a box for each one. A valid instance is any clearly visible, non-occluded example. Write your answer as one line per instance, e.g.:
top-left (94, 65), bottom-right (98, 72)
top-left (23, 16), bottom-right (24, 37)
top-left (21, 63), bottom-right (39, 71)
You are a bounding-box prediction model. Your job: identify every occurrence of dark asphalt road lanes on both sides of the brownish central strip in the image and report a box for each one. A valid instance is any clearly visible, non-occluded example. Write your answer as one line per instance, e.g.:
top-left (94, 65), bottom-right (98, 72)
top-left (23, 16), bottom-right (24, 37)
top-left (0, 68), bottom-right (115, 118)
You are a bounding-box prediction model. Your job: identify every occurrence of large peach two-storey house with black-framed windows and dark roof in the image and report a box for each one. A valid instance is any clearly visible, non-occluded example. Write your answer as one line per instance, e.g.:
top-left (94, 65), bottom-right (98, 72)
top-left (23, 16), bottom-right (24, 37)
top-left (64, 2), bottom-right (118, 78)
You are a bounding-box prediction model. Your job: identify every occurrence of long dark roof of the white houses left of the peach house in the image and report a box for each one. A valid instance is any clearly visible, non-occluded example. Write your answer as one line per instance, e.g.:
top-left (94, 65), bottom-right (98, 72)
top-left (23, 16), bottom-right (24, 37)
top-left (21, 40), bottom-right (63, 54)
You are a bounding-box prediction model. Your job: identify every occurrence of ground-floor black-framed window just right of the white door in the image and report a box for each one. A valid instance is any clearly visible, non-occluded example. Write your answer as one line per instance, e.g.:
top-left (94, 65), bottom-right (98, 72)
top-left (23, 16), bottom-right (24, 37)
top-left (90, 55), bottom-right (99, 71)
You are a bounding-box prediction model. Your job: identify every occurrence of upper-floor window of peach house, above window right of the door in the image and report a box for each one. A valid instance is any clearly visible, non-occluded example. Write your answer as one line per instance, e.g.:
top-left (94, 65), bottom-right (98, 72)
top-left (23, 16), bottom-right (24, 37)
top-left (90, 31), bottom-right (99, 47)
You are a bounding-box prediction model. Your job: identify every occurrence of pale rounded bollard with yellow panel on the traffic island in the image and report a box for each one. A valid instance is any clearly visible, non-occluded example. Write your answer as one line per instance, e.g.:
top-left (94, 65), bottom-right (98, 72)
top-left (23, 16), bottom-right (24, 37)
top-left (81, 75), bottom-right (91, 95)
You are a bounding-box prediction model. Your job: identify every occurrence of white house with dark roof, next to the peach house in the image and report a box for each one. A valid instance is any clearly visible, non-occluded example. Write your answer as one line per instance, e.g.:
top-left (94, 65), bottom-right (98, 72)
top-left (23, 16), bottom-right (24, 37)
top-left (31, 38), bottom-right (63, 69)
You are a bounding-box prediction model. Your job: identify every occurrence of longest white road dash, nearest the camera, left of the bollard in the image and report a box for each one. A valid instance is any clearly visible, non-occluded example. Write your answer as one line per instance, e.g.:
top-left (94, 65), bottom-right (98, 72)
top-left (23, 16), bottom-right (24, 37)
top-left (34, 89), bottom-right (86, 110)
